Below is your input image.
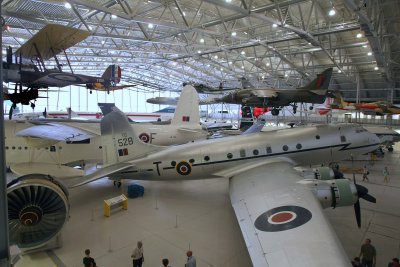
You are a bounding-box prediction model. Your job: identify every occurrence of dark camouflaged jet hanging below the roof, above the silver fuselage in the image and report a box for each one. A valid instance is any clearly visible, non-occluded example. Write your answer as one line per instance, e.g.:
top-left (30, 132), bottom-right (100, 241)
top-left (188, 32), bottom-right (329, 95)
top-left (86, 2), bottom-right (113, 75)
top-left (215, 68), bottom-right (332, 116)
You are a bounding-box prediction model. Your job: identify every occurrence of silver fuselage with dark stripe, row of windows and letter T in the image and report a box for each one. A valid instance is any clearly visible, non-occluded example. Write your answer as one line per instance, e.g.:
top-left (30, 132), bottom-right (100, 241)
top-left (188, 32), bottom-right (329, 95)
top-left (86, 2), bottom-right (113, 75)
top-left (102, 124), bottom-right (380, 183)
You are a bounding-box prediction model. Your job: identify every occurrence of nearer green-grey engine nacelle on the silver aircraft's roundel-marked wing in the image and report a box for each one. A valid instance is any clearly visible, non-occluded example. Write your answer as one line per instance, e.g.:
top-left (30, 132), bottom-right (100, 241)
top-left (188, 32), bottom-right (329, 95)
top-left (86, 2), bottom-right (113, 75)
top-left (314, 179), bottom-right (358, 208)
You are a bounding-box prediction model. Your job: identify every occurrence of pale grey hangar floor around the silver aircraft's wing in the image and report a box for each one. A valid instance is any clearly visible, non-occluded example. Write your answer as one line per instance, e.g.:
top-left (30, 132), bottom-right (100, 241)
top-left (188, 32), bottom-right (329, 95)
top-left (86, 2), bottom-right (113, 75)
top-left (11, 145), bottom-right (400, 267)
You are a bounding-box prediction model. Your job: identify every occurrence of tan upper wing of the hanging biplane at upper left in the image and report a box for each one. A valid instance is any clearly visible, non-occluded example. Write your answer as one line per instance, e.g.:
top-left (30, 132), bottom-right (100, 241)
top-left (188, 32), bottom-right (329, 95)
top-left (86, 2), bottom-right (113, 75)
top-left (16, 24), bottom-right (90, 60)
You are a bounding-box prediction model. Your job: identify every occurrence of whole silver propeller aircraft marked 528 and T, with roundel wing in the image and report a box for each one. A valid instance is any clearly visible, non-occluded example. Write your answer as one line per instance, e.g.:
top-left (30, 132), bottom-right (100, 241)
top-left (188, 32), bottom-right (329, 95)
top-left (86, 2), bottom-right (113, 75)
top-left (52, 108), bottom-right (379, 267)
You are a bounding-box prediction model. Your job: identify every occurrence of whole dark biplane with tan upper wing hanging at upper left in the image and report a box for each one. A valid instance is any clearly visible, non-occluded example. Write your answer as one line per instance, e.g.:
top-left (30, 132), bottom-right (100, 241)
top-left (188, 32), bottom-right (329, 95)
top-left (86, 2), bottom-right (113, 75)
top-left (3, 24), bottom-right (135, 117)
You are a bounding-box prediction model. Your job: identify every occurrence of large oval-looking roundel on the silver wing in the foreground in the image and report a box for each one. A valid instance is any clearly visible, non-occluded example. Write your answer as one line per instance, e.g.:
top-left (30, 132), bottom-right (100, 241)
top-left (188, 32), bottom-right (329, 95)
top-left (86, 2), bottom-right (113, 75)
top-left (254, 206), bottom-right (312, 232)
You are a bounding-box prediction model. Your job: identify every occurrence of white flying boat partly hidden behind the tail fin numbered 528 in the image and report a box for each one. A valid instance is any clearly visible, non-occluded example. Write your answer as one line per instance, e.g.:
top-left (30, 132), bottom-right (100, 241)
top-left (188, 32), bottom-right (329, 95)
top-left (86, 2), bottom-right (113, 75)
top-left (4, 86), bottom-right (208, 178)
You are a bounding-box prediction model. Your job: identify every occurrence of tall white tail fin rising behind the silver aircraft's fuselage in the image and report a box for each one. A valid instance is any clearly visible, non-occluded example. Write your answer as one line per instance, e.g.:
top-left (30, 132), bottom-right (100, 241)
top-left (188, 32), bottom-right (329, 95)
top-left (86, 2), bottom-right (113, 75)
top-left (171, 85), bottom-right (200, 126)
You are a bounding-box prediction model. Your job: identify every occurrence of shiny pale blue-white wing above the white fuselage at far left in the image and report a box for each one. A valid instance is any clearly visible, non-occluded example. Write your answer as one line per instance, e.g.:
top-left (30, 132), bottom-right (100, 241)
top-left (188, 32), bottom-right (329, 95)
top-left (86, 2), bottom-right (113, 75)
top-left (16, 123), bottom-right (95, 142)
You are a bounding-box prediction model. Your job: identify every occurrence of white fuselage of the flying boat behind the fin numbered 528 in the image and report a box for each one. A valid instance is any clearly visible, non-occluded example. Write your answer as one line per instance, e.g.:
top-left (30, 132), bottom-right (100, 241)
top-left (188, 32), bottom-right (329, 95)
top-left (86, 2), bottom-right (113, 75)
top-left (4, 121), bottom-right (207, 166)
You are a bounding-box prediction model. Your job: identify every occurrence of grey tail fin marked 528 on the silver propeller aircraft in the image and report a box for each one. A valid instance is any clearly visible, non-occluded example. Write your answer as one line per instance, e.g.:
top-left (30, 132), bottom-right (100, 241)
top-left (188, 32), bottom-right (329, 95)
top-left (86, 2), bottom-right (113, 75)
top-left (100, 111), bottom-right (163, 167)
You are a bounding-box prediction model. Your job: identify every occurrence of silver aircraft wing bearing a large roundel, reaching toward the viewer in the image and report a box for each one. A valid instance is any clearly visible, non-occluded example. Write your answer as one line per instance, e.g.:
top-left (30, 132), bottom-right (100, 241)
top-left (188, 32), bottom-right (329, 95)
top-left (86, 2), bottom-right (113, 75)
top-left (230, 161), bottom-right (351, 267)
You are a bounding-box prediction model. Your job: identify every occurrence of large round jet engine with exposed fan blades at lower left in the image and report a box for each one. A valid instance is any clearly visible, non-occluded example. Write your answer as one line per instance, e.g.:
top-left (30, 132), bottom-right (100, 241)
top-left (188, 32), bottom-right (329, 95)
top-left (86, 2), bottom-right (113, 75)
top-left (7, 174), bottom-right (69, 249)
